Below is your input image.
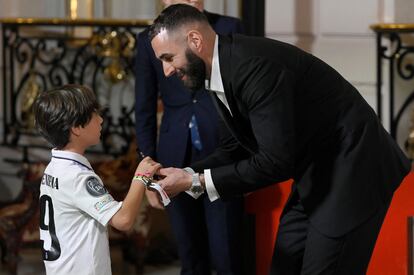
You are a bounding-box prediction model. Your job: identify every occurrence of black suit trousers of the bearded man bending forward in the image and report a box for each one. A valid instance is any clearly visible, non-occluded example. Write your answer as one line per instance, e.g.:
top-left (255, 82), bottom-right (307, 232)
top-left (270, 192), bottom-right (389, 275)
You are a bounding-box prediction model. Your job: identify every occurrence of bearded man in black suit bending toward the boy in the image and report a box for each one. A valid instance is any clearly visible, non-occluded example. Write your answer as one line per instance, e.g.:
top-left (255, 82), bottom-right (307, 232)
top-left (150, 5), bottom-right (410, 275)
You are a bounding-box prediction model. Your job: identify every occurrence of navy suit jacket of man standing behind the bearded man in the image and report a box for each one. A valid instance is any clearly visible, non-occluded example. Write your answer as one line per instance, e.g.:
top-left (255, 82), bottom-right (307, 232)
top-left (135, 11), bottom-right (242, 167)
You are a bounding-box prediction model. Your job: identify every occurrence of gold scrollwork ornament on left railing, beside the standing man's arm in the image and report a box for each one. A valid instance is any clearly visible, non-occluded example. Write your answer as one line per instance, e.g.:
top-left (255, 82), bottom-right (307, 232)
top-left (91, 31), bottom-right (135, 83)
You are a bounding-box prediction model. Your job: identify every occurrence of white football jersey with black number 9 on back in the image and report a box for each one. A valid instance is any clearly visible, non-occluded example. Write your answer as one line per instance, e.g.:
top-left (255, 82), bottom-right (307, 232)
top-left (39, 150), bottom-right (121, 275)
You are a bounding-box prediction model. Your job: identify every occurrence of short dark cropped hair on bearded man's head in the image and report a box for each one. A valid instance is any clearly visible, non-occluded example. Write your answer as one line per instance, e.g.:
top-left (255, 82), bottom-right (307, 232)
top-left (148, 4), bottom-right (209, 40)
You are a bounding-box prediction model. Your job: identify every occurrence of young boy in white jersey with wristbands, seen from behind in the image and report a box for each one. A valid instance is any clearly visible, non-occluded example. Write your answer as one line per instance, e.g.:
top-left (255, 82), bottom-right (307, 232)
top-left (34, 85), bottom-right (160, 275)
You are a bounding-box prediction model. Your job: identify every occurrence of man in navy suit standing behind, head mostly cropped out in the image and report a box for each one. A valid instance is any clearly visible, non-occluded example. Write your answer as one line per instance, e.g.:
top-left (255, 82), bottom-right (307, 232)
top-left (135, 0), bottom-right (244, 275)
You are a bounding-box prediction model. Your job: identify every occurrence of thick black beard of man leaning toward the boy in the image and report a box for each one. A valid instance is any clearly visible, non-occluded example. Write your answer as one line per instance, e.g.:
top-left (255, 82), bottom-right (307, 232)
top-left (179, 48), bottom-right (206, 91)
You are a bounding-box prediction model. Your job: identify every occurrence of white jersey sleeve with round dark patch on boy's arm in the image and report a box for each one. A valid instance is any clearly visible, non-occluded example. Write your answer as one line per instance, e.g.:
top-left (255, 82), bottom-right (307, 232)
top-left (68, 171), bottom-right (122, 226)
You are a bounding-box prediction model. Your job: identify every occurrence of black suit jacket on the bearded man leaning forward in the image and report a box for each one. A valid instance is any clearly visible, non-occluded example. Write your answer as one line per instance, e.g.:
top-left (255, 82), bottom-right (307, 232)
top-left (193, 35), bottom-right (410, 237)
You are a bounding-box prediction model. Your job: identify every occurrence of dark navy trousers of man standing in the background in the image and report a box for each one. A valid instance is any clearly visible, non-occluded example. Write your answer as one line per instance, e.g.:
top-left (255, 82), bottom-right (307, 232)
top-left (166, 139), bottom-right (244, 275)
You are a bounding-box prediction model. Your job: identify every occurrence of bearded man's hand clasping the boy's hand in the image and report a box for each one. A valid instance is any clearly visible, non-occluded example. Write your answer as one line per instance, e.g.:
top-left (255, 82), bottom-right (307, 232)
top-left (157, 168), bottom-right (192, 197)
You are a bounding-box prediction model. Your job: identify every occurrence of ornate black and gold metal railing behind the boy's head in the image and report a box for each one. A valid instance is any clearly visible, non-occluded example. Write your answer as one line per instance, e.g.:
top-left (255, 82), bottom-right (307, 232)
top-left (0, 18), bottom-right (151, 155)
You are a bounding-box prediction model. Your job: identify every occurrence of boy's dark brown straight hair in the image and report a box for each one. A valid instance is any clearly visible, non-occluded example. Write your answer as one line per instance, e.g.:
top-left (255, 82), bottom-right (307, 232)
top-left (33, 84), bottom-right (99, 149)
